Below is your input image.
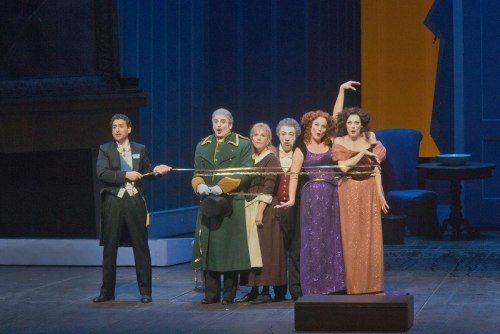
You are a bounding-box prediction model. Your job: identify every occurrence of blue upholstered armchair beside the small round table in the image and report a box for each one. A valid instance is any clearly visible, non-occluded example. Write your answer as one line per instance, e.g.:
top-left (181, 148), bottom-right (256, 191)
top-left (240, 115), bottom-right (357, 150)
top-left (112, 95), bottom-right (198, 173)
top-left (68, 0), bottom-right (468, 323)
top-left (375, 129), bottom-right (440, 236)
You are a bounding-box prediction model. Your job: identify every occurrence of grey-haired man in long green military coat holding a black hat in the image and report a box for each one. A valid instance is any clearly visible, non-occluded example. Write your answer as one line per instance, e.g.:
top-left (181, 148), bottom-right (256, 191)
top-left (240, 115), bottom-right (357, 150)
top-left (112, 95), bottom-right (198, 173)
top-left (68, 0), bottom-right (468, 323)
top-left (192, 109), bottom-right (253, 305)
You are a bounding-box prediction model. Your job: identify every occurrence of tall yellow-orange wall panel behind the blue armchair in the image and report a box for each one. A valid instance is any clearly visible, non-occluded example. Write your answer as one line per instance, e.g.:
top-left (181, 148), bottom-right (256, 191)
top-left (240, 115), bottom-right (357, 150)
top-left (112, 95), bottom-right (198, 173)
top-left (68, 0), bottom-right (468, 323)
top-left (361, 0), bottom-right (439, 157)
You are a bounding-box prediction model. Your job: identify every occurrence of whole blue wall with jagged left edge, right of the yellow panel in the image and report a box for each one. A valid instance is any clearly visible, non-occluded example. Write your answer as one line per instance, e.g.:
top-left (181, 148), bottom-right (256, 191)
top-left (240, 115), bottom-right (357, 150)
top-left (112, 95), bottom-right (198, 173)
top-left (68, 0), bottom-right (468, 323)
top-left (426, 0), bottom-right (500, 227)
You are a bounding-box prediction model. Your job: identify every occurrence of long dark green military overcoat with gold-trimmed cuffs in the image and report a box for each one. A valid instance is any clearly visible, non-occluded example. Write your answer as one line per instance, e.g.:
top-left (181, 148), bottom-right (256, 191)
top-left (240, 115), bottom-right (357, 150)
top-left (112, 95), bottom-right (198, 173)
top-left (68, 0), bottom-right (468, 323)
top-left (192, 133), bottom-right (253, 272)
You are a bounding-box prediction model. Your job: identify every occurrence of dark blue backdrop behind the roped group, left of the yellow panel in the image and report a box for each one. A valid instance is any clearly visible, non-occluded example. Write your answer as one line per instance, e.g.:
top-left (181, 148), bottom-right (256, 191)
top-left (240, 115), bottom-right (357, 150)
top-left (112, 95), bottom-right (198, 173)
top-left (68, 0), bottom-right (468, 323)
top-left (118, 0), bottom-right (361, 211)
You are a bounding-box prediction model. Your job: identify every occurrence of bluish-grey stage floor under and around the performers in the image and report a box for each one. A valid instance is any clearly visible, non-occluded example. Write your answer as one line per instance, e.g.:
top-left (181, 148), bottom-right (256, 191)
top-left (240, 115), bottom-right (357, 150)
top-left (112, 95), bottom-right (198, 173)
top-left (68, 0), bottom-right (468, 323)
top-left (0, 231), bottom-right (500, 334)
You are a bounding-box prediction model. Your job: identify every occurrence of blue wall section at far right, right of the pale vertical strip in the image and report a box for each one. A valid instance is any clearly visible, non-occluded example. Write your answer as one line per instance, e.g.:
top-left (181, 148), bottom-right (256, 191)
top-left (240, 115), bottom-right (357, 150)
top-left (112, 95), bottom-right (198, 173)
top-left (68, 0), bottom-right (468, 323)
top-left (463, 0), bottom-right (500, 227)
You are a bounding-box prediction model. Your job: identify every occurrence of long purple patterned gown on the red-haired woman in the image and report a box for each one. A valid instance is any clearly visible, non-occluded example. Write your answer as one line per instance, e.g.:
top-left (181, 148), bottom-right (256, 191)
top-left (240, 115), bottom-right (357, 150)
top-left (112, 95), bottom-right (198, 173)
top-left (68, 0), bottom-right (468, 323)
top-left (300, 148), bottom-right (346, 295)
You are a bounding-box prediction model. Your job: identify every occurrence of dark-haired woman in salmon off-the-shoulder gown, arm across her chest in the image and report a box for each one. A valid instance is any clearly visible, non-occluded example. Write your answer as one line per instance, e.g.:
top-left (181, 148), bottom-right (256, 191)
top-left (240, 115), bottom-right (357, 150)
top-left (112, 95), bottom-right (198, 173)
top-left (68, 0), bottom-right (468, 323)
top-left (332, 81), bottom-right (389, 294)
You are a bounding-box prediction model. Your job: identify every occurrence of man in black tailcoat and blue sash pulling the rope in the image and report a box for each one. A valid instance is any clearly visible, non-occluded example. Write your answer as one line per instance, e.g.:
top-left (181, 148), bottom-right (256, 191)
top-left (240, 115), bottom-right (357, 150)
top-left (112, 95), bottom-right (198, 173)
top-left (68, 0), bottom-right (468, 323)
top-left (94, 114), bottom-right (172, 303)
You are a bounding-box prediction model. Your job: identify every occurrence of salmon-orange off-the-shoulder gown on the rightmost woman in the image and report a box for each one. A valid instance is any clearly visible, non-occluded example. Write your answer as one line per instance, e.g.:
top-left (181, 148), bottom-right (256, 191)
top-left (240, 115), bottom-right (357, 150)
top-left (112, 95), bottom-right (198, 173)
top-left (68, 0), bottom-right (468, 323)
top-left (333, 144), bottom-right (385, 294)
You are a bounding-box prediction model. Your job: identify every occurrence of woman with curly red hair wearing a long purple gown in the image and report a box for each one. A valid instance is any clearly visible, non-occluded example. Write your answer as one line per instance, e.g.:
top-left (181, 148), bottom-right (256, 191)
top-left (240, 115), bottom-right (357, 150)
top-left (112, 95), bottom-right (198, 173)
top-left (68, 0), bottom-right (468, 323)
top-left (279, 110), bottom-right (345, 295)
